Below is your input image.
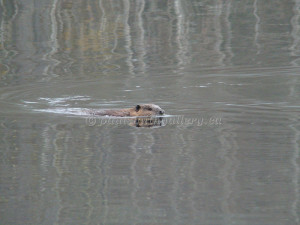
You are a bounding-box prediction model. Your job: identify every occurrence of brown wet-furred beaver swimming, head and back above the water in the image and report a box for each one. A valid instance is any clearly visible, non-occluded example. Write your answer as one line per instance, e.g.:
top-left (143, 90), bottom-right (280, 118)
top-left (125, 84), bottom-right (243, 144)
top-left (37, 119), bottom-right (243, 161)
top-left (91, 104), bottom-right (165, 117)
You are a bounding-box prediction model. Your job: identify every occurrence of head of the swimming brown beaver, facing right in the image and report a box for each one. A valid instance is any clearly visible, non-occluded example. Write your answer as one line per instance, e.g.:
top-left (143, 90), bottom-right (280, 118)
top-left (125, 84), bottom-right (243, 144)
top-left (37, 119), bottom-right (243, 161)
top-left (130, 104), bottom-right (165, 116)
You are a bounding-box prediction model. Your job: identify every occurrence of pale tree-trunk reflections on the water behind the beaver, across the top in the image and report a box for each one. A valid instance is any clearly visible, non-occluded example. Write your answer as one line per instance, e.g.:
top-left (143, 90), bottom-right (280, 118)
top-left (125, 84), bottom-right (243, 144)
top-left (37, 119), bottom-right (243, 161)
top-left (1, 0), bottom-right (298, 82)
